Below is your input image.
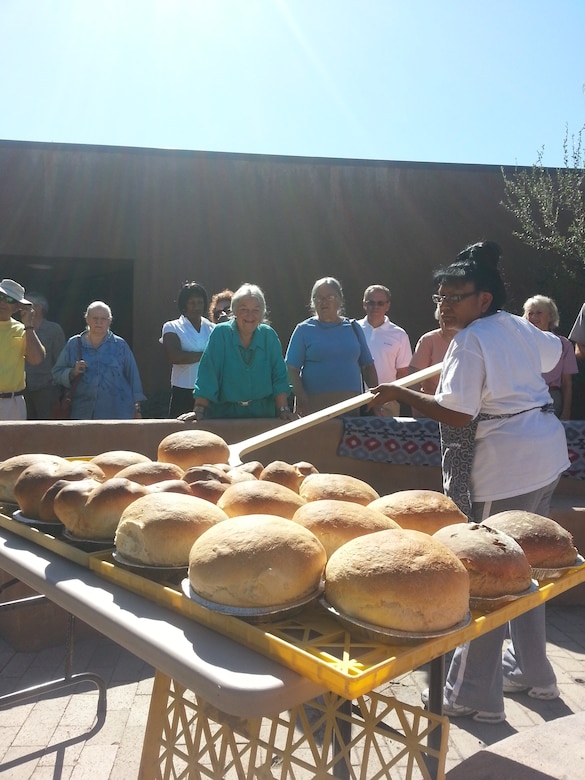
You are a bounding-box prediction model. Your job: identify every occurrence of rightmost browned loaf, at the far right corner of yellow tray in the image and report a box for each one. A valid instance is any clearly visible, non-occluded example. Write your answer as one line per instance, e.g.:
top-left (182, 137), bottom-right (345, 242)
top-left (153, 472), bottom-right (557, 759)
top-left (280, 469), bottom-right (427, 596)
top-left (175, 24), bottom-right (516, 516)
top-left (484, 509), bottom-right (579, 569)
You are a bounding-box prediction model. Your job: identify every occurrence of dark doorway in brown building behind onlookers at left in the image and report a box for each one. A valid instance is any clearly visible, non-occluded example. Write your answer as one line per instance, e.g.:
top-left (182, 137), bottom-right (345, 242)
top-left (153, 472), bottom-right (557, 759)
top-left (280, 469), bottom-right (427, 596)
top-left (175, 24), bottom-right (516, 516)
top-left (0, 255), bottom-right (134, 346)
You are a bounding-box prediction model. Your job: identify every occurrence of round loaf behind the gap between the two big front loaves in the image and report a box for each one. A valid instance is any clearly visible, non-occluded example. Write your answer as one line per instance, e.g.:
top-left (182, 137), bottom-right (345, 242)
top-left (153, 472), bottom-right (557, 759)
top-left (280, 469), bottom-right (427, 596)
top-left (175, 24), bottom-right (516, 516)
top-left (292, 498), bottom-right (400, 558)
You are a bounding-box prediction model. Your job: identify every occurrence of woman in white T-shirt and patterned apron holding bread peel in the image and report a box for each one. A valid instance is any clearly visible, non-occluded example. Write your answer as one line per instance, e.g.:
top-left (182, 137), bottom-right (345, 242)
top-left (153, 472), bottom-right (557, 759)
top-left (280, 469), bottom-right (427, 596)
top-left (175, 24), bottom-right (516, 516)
top-left (373, 241), bottom-right (569, 723)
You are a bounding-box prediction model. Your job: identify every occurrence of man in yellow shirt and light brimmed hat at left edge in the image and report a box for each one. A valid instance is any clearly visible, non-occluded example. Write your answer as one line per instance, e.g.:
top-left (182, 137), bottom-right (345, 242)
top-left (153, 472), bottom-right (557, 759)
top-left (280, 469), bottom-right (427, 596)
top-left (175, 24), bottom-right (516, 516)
top-left (0, 279), bottom-right (45, 420)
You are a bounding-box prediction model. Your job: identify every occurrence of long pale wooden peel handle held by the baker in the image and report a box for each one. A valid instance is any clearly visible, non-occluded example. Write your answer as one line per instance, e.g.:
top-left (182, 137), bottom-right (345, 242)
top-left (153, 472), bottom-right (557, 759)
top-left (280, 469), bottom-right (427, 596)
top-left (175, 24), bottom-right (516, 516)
top-left (229, 363), bottom-right (443, 466)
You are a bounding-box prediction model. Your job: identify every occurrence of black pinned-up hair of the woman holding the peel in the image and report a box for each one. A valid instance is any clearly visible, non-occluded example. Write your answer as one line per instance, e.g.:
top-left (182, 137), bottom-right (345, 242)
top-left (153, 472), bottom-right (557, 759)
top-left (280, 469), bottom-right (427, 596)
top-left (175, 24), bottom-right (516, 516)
top-left (433, 241), bottom-right (507, 315)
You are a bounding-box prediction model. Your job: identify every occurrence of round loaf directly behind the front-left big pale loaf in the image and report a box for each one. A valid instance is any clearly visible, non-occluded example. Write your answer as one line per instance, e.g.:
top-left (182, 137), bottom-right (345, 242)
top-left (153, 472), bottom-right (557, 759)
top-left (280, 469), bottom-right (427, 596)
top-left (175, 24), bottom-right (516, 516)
top-left (217, 479), bottom-right (305, 520)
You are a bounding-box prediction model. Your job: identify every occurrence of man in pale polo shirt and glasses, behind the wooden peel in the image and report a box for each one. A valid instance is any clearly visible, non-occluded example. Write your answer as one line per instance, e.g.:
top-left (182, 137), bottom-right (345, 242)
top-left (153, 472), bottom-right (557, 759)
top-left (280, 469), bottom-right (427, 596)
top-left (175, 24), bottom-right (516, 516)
top-left (358, 284), bottom-right (412, 417)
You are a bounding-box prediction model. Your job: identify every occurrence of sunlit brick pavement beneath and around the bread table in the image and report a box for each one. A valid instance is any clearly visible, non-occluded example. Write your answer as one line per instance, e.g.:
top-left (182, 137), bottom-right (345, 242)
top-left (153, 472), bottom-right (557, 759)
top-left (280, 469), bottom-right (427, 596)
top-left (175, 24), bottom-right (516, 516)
top-left (0, 601), bottom-right (585, 780)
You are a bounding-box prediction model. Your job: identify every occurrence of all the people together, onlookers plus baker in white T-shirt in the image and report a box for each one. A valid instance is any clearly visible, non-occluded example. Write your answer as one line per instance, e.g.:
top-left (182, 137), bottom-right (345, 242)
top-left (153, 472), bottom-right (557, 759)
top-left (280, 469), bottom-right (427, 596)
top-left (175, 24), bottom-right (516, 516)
top-left (0, 241), bottom-right (585, 723)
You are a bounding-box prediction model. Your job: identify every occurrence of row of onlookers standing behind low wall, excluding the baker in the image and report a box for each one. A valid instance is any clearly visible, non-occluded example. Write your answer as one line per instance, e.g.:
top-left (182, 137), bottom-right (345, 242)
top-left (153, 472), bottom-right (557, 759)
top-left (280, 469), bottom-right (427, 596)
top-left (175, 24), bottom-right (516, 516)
top-left (0, 266), bottom-right (585, 420)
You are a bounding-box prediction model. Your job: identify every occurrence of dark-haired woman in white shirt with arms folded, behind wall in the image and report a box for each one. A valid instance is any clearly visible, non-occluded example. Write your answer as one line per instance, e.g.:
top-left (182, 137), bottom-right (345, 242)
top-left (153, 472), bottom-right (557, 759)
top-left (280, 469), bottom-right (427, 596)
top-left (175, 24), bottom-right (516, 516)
top-left (159, 282), bottom-right (213, 417)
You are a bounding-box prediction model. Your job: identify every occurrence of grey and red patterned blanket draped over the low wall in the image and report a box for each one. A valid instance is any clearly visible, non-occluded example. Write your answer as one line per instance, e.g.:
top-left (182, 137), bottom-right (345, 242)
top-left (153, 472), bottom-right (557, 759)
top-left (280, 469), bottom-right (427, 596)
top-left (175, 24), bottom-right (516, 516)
top-left (337, 417), bottom-right (585, 479)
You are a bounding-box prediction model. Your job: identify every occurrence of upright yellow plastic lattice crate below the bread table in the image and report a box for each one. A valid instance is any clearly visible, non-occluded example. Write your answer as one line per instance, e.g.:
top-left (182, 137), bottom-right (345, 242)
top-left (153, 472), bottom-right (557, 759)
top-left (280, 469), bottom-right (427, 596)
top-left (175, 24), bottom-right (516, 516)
top-left (139, 672), bottom-right (449, 780)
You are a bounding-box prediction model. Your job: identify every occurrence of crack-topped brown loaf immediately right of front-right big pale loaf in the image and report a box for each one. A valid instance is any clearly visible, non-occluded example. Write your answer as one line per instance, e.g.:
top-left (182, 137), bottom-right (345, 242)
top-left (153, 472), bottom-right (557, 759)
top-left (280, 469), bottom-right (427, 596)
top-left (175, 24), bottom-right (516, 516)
top-left (433, 523), bottom-right (532, 598)
